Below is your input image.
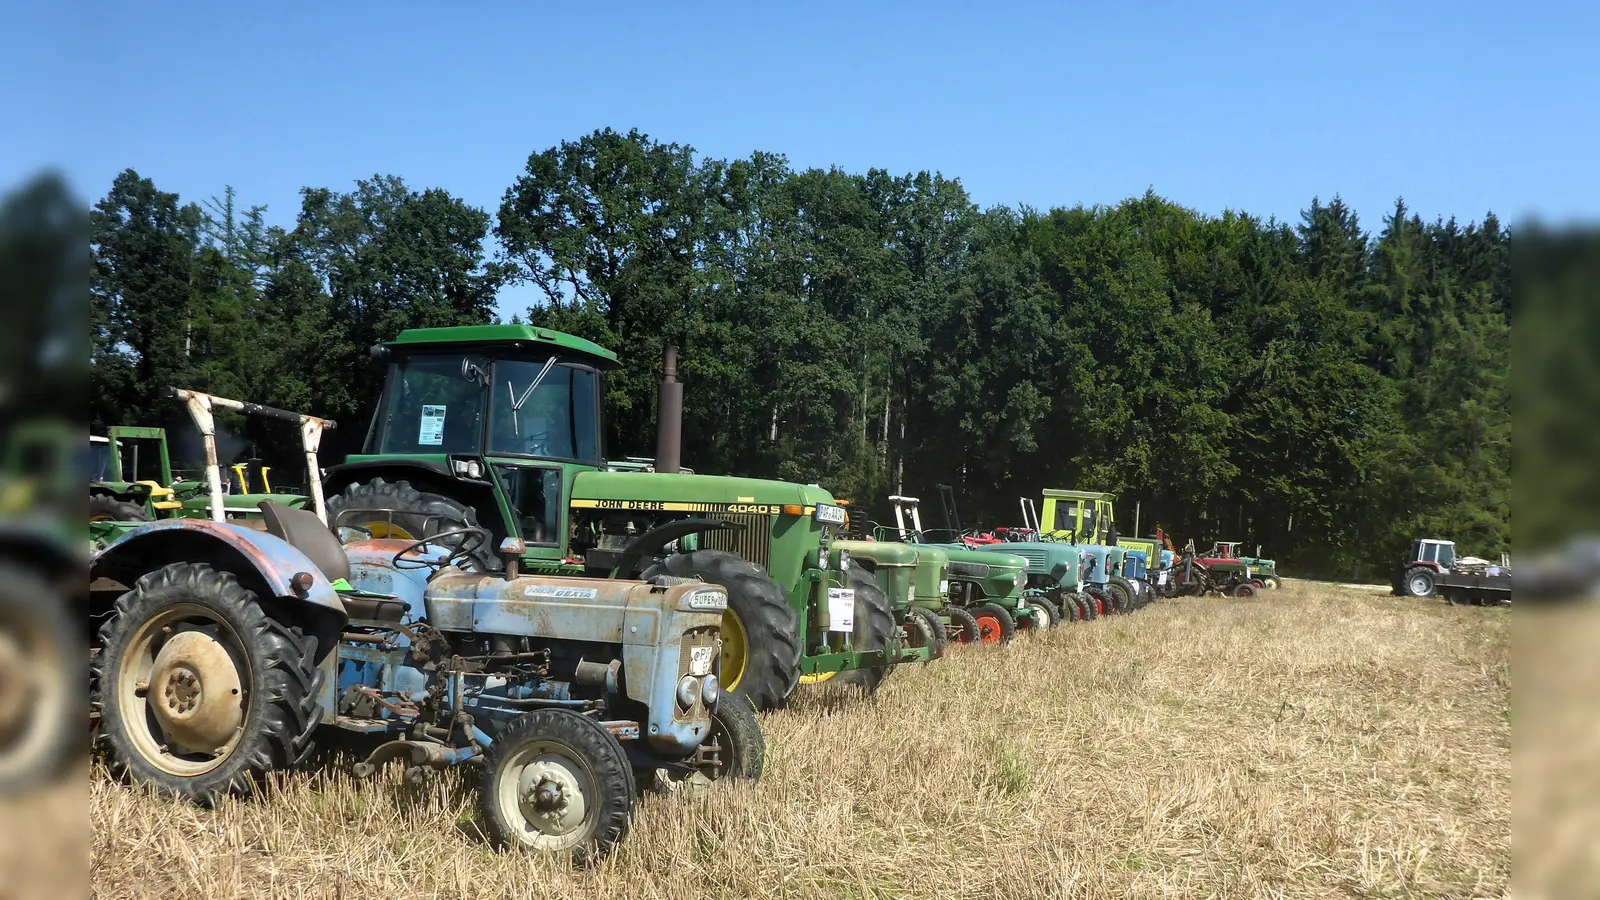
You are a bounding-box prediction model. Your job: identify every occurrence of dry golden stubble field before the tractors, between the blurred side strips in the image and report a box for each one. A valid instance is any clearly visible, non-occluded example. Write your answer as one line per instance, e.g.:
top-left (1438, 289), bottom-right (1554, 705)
top-left (90, 583), bottom-right (1510, 900)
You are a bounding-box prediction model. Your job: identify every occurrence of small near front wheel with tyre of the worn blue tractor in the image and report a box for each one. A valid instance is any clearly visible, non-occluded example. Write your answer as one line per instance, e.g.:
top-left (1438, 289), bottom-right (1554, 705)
top-left (478, 709), bottom-right (638, 865)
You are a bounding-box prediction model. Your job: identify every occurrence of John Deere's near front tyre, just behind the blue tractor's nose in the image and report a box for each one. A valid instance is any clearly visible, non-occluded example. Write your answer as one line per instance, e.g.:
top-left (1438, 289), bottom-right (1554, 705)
top-left (640, 549), bottom-right (800, 713)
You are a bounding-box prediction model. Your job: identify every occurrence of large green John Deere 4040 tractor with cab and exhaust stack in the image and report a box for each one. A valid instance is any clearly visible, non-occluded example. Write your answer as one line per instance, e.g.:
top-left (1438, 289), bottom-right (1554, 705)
top-left (323, 325), bottom-right (908, 709)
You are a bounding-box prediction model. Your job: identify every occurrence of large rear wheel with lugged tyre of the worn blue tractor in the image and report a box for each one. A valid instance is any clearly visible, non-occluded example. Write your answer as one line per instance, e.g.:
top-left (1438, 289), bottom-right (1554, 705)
top-left (90, 562), bottom-right (323, 806)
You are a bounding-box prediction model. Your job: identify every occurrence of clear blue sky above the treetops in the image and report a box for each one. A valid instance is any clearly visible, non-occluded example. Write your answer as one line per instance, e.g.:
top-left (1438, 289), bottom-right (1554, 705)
top-left (0, 0), bottom-right (1600, 311)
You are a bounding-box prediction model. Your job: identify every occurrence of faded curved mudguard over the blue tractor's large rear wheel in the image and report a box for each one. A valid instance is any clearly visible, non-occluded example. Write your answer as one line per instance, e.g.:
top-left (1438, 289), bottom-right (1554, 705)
top-left (90, 519), bottom-right (349, 661)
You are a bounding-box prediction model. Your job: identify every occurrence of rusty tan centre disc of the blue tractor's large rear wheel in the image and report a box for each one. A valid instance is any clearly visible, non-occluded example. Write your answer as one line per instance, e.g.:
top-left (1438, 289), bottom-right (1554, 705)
top-left (146, 631), bottom-right (245, 753)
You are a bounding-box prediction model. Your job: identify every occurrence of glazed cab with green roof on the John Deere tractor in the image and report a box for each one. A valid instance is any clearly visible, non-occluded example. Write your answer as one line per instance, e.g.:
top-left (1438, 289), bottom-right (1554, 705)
top-left (328, 325), bottom-right (614, 560)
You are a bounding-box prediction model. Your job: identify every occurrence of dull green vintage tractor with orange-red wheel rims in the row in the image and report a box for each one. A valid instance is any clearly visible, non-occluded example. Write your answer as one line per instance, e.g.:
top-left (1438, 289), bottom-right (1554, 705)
top-left (875, 495), bottom-right (1043, 644)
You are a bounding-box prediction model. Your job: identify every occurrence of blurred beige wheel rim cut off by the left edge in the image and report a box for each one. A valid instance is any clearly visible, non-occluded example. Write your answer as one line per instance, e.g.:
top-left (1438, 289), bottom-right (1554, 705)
top-left (0, 615), bottom-right (69, 783)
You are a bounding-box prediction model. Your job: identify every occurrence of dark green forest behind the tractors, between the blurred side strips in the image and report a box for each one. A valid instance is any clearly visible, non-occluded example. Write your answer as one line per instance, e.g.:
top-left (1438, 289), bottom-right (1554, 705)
top-left (90, 130), bottom-right (1512, 578)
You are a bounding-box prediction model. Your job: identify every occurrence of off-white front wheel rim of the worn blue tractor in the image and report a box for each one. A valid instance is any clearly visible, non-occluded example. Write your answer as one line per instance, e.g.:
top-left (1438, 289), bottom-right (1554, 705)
top-left (494, 740), bottom-right (598, 850)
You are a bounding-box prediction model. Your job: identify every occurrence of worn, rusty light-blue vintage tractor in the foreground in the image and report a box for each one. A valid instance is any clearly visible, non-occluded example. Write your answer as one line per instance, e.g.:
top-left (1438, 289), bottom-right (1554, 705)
top-left (88, 397), bottom-right (765, 862)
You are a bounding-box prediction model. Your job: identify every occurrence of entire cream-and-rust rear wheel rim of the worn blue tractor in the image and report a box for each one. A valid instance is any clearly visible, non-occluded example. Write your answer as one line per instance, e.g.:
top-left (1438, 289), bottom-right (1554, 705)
top-left (117, 604), bottom-right (250, 777)
